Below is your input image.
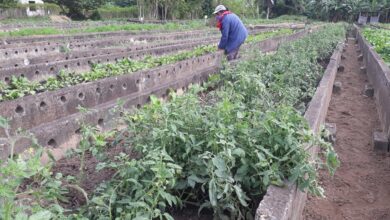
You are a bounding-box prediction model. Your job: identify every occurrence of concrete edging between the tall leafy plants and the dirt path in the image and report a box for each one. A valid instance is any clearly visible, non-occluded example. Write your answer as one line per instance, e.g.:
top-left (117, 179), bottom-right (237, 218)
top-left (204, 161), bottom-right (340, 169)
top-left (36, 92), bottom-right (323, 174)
top-left (255, 42), bottom-right (342, 220)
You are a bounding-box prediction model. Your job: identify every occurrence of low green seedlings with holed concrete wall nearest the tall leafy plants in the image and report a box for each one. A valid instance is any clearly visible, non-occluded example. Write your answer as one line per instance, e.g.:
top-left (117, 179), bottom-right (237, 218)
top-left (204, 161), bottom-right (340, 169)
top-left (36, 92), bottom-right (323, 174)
top-left (1, 27), bottom-right (296, 159)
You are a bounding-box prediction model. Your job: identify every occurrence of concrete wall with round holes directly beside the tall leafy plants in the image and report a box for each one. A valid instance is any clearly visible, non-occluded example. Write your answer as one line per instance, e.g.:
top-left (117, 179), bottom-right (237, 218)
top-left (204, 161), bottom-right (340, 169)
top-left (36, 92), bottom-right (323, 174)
top-left (0, 27), bottom-right (316, 158)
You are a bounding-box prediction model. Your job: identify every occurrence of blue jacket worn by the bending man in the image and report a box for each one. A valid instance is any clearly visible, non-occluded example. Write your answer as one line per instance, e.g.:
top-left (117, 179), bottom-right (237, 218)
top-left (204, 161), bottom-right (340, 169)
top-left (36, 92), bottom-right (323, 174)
top-left (218, 14), bottom-right (248, 53)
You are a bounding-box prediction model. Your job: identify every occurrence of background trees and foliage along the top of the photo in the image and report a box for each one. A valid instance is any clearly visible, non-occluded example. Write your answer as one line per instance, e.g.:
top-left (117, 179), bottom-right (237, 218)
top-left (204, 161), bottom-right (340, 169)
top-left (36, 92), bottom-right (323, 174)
top-left (0, 0), bottom-right (390, 21)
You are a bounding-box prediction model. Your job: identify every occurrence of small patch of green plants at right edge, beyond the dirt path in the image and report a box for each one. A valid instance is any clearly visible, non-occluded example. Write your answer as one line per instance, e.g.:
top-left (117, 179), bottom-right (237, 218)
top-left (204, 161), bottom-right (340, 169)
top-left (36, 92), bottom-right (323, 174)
top-left (363, 28), bottom-right (390, 65)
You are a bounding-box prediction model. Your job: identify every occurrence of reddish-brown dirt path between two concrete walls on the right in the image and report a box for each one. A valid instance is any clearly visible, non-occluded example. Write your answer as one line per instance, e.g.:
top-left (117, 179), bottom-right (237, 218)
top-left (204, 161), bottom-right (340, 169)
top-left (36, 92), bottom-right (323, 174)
top-left (303, 40), bottom-right (390, 220)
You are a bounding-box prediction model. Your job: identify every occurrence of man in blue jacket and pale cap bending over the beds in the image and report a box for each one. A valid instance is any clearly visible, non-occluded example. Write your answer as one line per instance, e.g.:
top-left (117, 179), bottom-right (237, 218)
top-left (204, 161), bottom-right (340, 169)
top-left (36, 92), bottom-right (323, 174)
top-left (213, 5), bottom-right (248, 60)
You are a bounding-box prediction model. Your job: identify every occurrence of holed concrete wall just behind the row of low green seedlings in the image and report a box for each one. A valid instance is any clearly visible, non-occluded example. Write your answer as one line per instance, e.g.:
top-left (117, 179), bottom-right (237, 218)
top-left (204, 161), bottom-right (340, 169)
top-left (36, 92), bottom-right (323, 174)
top-left (0, 29), bottom-right (291, 82)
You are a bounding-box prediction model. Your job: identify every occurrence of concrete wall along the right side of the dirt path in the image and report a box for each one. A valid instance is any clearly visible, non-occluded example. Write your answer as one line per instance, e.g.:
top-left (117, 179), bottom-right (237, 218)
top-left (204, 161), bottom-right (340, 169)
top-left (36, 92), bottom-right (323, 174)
top-left (354, 26), bottom-right (390, 138)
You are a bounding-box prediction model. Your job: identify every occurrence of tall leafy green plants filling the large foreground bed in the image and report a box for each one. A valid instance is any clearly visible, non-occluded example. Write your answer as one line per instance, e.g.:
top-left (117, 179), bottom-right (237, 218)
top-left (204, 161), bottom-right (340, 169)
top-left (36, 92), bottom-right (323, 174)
top-left (0, 25), bottom-right (345, 219)
